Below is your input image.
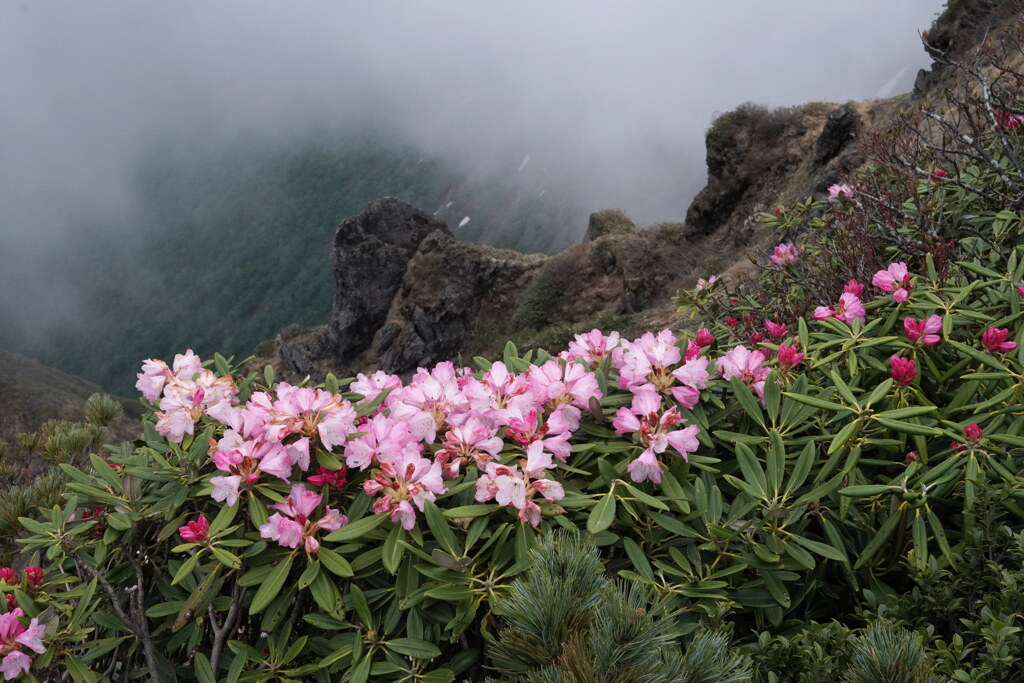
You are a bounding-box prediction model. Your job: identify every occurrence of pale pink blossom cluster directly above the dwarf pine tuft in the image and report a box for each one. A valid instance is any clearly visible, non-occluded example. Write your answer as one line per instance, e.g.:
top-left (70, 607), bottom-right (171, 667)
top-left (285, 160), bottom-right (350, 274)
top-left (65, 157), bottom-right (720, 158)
top-left (476, 441), bottom-right (565, 526)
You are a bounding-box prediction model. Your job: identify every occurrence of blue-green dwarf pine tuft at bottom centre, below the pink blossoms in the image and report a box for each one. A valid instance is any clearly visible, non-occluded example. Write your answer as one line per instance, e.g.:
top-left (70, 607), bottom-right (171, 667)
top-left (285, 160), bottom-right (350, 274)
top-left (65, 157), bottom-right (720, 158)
top-left (487, 531), bottom-right (750, 683)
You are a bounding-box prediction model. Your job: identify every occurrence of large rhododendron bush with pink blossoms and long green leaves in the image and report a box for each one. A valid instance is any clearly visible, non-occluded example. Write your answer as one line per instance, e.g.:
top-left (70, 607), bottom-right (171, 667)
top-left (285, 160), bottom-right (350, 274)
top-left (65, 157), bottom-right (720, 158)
top-left (12, 28), bottom-right (1024, 682)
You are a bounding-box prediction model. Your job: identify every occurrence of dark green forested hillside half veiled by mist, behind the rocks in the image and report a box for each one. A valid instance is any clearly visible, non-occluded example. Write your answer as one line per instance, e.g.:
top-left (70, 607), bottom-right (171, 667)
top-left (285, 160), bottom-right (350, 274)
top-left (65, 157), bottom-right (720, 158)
top-left (0, 130), bottom-right (587, 394)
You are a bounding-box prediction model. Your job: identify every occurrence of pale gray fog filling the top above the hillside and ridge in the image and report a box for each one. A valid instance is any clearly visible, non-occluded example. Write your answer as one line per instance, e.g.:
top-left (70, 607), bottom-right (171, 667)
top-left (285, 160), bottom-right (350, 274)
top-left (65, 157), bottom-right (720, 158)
top-left (0, 0), bottom-right (942, 374)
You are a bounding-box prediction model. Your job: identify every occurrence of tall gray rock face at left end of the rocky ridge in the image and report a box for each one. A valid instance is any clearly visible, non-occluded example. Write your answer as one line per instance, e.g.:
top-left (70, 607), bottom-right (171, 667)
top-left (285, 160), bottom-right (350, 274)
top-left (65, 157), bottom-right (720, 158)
top-left (328, 198), bottom-right (451, 366)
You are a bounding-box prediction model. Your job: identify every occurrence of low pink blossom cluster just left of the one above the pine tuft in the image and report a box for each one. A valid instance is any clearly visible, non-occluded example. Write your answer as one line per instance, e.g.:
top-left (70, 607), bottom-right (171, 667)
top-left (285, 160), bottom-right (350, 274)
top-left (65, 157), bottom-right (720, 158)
top-left (362, 450), bottom-right (447, 530)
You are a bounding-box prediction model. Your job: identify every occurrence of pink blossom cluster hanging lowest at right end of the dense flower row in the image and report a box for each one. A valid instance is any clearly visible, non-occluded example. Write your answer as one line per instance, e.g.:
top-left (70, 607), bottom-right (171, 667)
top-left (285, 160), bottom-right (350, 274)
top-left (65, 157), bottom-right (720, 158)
top-left (611, 391), bottom-right (700, 483)
